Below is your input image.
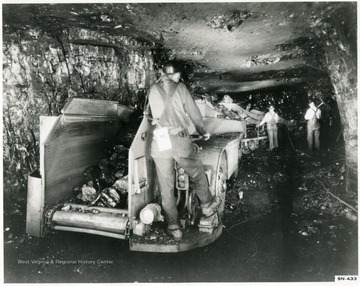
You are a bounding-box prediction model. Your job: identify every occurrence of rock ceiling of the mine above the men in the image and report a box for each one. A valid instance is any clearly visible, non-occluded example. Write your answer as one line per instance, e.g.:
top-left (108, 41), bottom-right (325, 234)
top-left (3, 2), bottom-right (352, 91)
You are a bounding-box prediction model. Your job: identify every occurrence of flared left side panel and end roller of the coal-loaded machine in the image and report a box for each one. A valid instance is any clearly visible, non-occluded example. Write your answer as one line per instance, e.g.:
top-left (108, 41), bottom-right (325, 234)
top-left (26, 98), bottom-right (132, 237)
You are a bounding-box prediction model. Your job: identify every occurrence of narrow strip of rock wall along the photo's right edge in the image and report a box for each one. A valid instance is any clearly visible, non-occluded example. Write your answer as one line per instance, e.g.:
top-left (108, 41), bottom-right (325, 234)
top-left (311, 3), bottom-right (358, 192)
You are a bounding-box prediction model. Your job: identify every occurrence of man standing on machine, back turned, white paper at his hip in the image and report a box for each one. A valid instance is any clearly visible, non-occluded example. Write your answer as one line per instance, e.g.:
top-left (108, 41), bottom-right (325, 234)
top-left (145, 61), bottom-right (221, 240)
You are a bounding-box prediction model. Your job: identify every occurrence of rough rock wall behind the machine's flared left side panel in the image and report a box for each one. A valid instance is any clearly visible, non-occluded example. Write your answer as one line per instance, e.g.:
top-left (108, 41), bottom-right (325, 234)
top-left (3, 26), bottom-right (155, 193)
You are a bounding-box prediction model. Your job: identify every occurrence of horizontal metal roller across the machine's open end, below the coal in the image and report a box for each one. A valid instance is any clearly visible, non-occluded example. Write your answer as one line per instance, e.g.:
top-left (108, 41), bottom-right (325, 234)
top-left (51, 211), bottom-right (128, 233)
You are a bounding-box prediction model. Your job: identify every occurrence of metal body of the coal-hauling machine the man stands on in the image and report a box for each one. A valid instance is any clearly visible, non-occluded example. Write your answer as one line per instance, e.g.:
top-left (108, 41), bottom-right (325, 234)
top-left (26, 98), bottom-right (244, 252)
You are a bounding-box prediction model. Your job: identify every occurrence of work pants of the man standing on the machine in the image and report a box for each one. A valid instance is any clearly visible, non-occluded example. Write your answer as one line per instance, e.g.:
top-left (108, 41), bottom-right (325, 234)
top-left (153, 133), bottom-right (212, 229)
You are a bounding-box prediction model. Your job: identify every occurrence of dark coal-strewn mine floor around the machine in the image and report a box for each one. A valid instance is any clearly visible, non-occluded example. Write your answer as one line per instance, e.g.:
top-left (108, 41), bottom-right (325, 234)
top-left (4, 128), bottom-right (358, 283)
